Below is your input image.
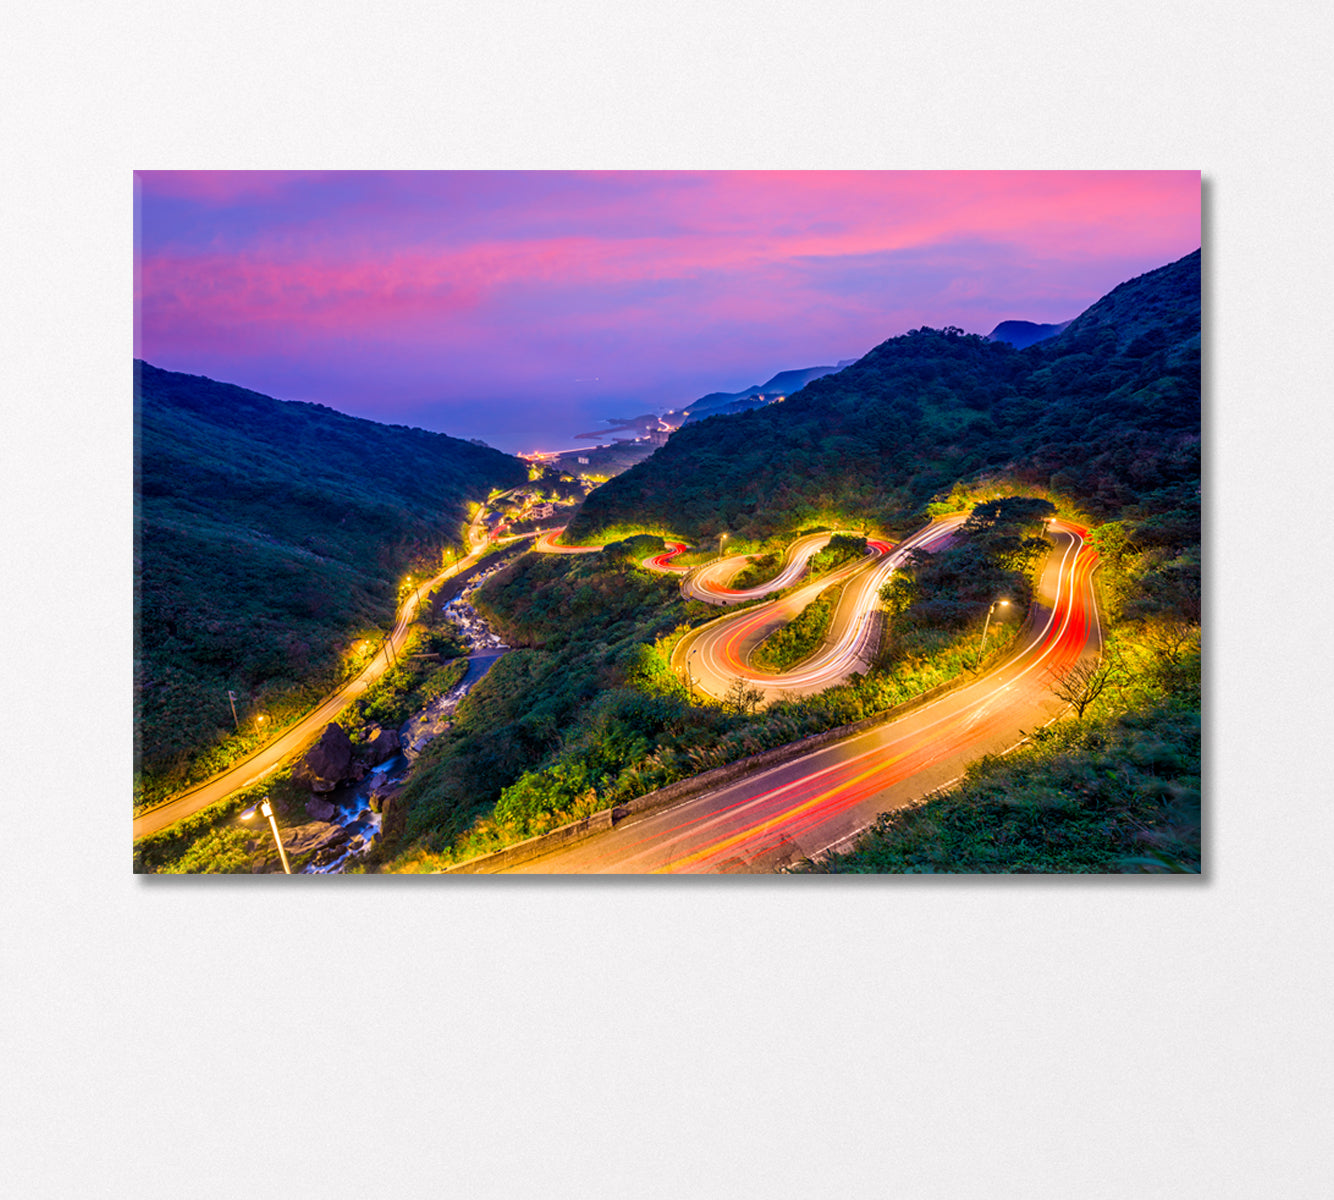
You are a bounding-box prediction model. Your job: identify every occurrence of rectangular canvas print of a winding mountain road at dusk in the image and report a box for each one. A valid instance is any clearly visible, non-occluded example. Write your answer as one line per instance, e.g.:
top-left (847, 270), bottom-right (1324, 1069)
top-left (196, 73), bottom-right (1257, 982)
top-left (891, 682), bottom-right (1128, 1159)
top-left (133, 171), bottom-right (1202, 876)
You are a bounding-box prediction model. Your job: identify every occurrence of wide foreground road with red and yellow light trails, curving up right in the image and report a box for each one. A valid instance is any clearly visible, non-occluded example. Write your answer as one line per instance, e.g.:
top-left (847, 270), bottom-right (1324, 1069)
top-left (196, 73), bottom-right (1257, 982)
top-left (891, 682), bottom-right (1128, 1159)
top-left (514, 521), bottom-right (1102, 875)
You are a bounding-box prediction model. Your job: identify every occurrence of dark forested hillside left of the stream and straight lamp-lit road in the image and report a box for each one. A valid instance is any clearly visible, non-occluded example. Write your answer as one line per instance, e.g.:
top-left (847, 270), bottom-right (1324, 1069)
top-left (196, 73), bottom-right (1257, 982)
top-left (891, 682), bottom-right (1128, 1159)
top-left (135, 361), bottom-right (527, 789)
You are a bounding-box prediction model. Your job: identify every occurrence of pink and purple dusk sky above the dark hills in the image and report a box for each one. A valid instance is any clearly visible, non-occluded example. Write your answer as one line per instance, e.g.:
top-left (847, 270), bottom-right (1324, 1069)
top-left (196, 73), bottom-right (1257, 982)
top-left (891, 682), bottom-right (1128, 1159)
top-left (135, 171), bottom-right (1201, 452)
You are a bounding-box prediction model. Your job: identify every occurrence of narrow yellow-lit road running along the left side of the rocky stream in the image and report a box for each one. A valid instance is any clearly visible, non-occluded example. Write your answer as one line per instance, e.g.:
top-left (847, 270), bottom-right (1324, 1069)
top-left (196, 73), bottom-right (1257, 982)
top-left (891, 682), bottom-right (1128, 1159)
top-left (135, 553), bottom-right (479, 840)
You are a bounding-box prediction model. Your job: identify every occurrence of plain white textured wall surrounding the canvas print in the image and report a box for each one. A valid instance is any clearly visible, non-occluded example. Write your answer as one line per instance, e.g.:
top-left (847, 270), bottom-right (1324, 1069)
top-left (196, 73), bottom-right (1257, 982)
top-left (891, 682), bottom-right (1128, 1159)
top-left (0, 0), bottom-right (1334, 1200)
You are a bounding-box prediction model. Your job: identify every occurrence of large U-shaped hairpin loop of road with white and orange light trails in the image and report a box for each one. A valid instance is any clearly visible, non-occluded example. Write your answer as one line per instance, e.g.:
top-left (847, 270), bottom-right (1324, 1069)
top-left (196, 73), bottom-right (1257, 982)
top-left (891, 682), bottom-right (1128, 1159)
top-left (672, 513), bottom-right (964, 704)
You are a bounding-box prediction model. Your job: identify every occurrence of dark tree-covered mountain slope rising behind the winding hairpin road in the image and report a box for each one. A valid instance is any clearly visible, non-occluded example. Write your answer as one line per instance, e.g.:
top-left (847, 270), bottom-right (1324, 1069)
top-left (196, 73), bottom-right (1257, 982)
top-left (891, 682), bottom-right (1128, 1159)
top-left (570, 251), bottom-right (1199, 541)
